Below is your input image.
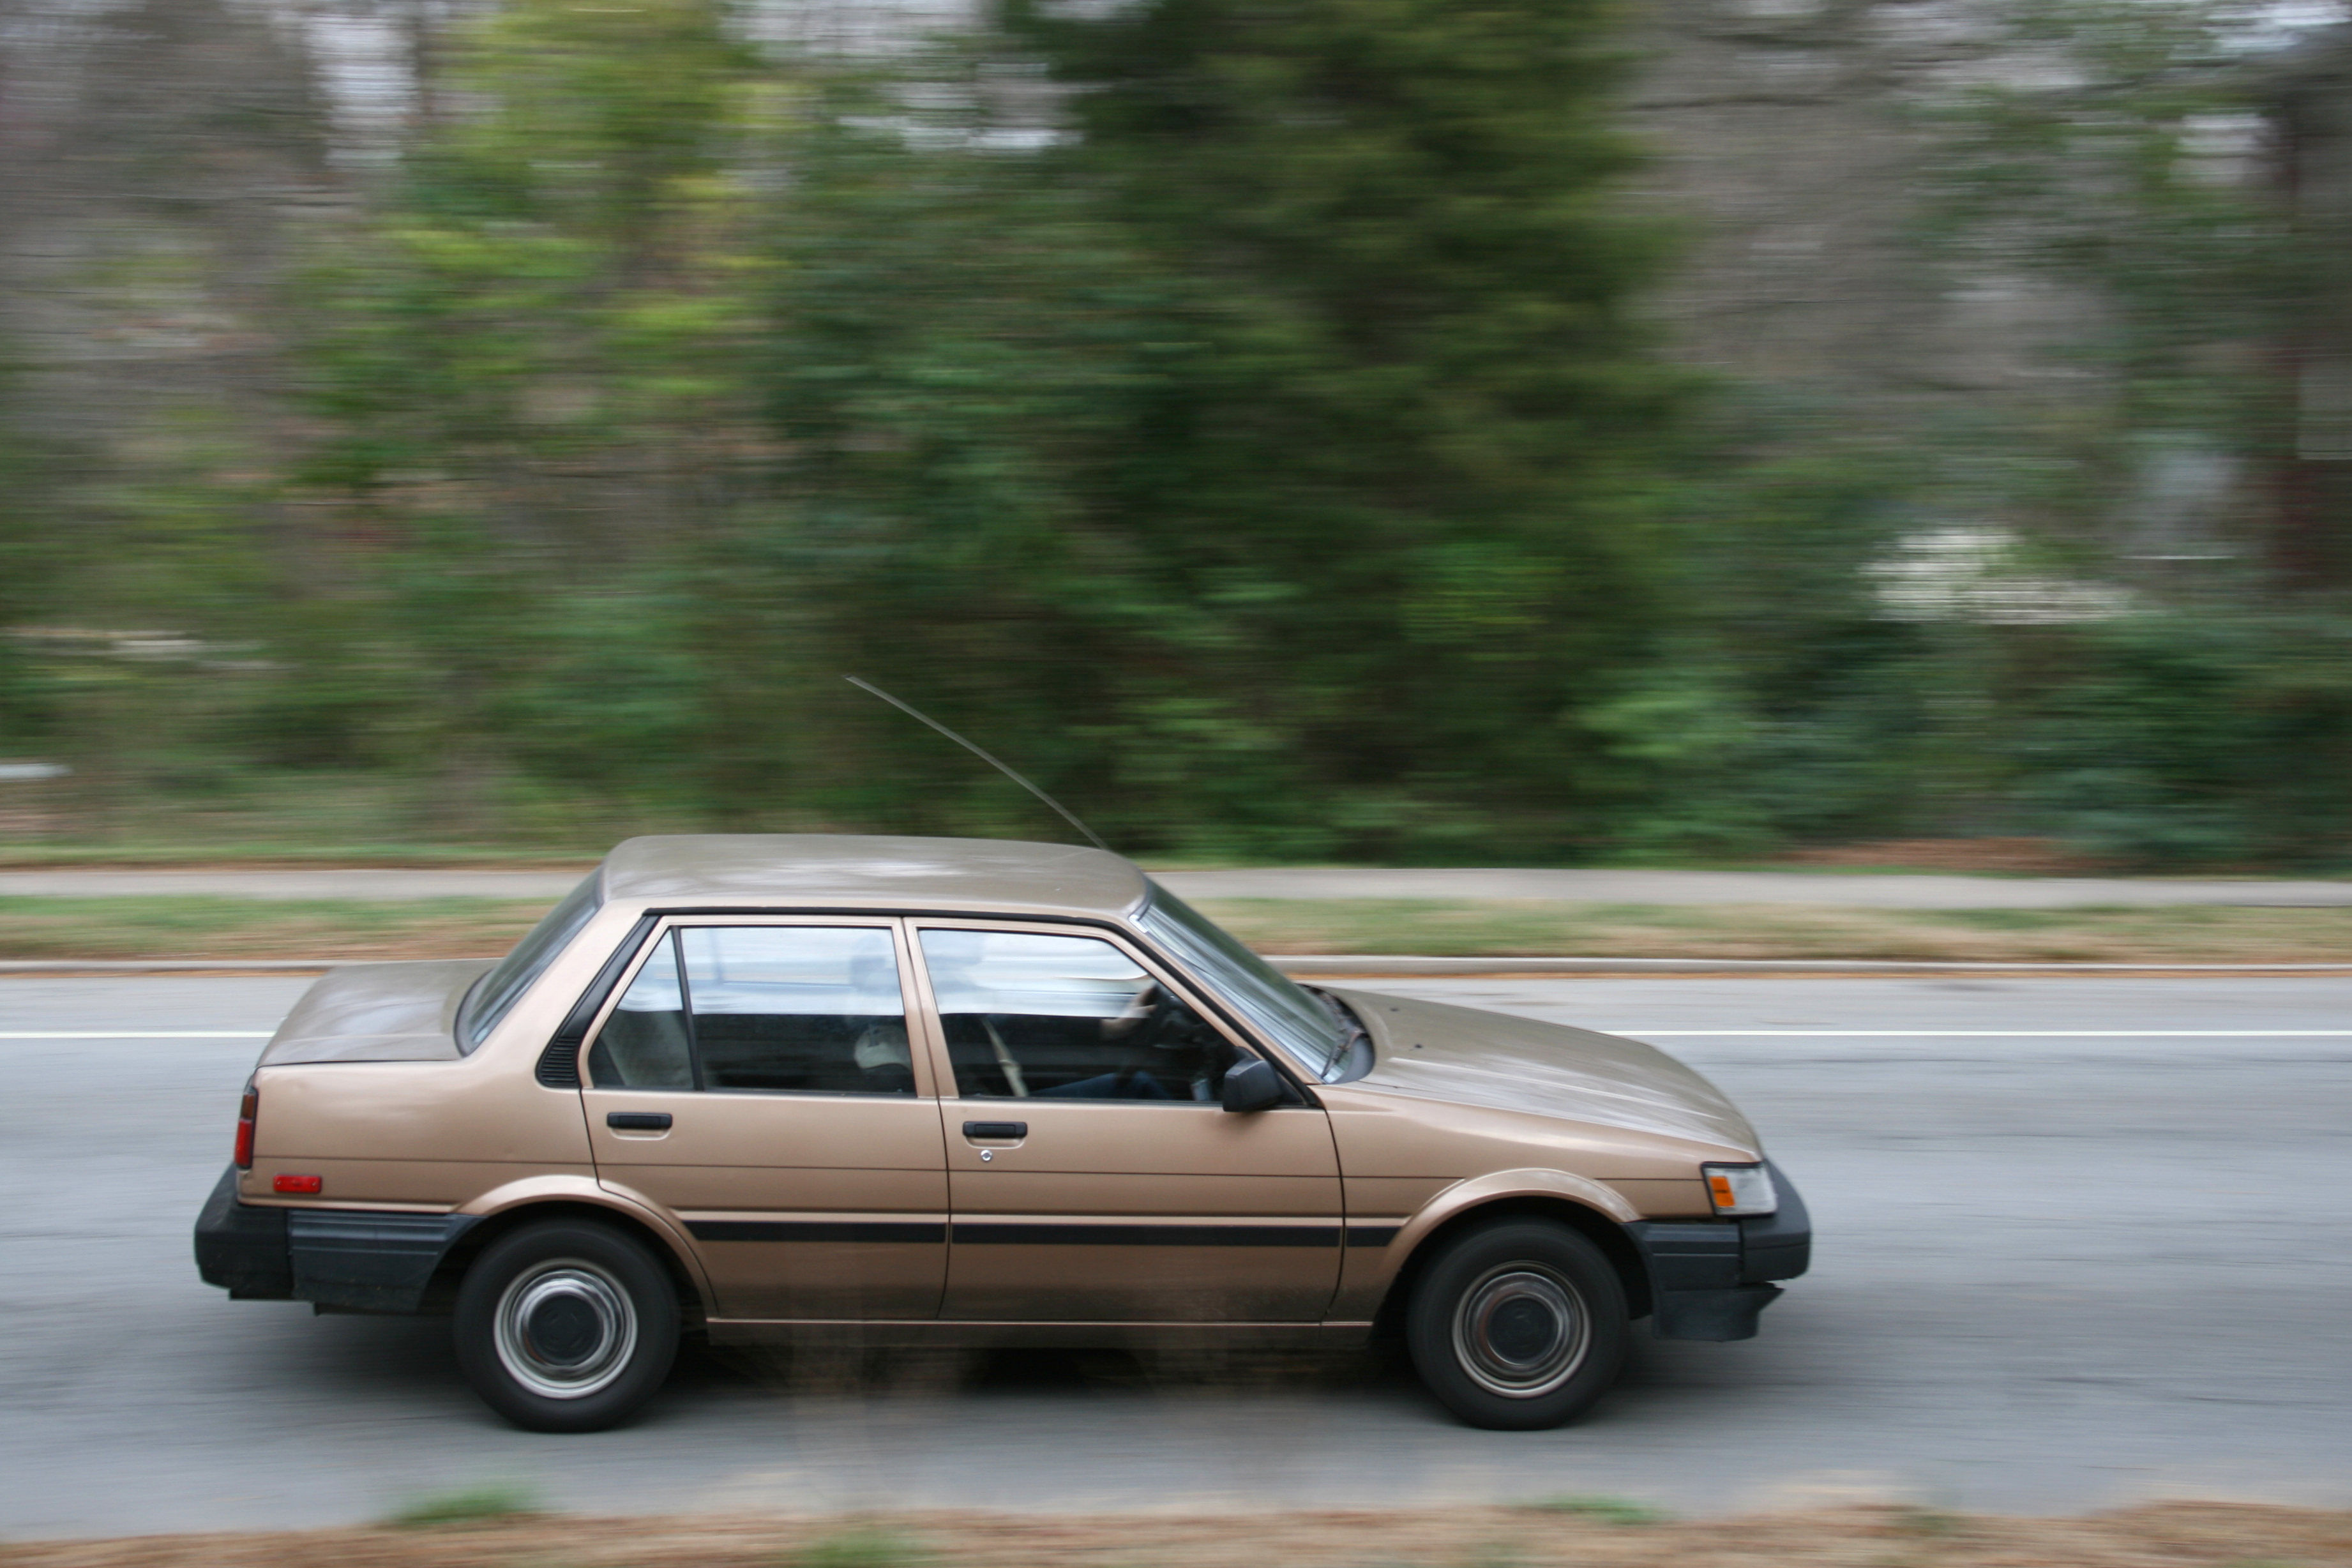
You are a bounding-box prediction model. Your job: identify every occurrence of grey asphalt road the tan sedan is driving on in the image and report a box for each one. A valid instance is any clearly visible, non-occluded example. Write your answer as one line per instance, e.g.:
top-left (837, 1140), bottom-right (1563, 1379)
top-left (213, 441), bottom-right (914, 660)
top-left (0, 978), bottom-right (2352, 1537)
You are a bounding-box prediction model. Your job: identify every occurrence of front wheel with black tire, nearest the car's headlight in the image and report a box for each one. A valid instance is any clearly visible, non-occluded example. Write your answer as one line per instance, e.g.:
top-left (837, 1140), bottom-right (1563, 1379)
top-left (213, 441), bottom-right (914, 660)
top-left (1404, 1220), bottom-right (1627, 1431)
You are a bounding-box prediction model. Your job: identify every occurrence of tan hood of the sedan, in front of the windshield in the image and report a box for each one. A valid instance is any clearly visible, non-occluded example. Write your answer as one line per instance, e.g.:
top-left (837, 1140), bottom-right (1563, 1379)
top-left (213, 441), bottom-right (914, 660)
top-left (1331, 990), bottom-right (1761, 1154)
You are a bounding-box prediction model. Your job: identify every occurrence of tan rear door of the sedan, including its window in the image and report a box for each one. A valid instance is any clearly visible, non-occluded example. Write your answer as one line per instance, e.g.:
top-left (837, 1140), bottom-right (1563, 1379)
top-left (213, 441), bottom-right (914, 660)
top-left (581, 917), bottom-right (948, 1319)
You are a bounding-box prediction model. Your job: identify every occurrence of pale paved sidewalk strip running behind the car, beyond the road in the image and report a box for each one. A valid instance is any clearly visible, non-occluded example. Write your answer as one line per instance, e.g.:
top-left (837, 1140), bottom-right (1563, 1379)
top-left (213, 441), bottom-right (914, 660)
top-left (13, 865), bottom-right (2352, 910)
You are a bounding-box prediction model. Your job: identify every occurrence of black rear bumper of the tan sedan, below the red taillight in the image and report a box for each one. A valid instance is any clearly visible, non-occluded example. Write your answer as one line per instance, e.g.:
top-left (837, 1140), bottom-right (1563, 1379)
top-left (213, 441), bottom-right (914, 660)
top-left (195, 1166), bottom-right (475, 1312)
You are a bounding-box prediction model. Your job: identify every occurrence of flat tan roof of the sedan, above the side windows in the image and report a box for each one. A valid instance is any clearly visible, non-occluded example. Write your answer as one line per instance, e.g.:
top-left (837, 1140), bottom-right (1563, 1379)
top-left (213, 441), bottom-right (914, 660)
top-left (602, 832), bottom-right (1145, 919)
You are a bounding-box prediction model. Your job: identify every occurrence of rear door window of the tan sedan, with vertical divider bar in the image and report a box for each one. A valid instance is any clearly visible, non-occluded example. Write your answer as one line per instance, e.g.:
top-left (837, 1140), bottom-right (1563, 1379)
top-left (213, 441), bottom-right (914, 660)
top-left (588, 926), bottom-right (915, 1096)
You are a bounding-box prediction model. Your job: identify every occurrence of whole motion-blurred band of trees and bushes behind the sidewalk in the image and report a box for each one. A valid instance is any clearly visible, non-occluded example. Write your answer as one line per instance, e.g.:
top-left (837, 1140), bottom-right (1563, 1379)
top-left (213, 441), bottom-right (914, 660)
top-left (0, 0), bottom-right (2352, 870)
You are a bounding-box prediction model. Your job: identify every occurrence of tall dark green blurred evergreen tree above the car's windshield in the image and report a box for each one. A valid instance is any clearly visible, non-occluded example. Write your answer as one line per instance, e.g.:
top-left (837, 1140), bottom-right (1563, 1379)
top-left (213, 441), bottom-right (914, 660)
top-left (1034, 0), bottom-right (1679, 858)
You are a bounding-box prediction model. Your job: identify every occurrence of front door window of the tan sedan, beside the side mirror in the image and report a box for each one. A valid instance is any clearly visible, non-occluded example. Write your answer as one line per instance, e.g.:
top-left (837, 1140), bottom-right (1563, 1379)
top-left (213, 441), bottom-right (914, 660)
top-left (922, 928), bottom-right (1237, 1105)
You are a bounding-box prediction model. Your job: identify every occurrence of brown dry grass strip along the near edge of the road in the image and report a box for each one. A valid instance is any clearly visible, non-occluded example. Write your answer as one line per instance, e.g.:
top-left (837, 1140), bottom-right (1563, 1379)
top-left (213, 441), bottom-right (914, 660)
top-left (0, 1502), bottom-right (2352, 1568)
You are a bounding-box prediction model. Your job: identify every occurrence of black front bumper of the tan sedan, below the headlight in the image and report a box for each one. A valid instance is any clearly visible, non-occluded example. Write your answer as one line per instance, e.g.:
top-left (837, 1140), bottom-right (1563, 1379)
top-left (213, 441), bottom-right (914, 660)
top-left (1625, 1161), bottom-right (1813, 1340)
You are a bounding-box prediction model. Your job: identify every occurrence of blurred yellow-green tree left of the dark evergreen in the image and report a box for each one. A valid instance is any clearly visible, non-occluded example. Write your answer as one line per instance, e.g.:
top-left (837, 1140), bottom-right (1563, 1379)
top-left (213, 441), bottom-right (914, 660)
top-left (282, 0), bottom-right (767, 830)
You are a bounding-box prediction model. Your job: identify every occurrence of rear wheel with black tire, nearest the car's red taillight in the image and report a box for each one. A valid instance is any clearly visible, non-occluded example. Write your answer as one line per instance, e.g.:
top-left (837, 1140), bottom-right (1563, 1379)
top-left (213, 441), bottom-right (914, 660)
top-left (456, 1220), bottom-right (677, 1431)
